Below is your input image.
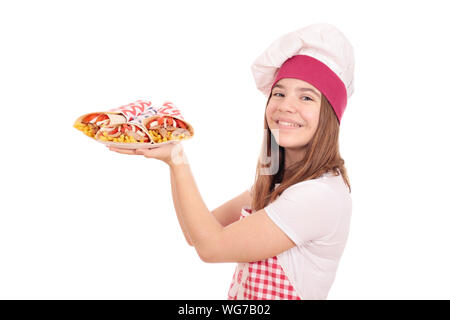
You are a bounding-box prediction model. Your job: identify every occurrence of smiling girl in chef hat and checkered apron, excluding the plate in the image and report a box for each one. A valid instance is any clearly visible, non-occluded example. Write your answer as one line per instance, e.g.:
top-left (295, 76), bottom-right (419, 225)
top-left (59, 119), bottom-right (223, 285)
top-left (110, 24), bottom-right (354, 300)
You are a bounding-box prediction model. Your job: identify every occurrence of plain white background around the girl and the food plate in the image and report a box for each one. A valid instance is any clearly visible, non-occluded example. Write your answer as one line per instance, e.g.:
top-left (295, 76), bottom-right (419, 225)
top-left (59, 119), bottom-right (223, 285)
top-left (0, 0), bottom-right (450, 299)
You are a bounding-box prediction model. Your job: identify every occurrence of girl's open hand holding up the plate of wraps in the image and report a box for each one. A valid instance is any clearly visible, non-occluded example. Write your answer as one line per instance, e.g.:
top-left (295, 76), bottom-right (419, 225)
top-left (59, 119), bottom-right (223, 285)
top-left (108, 142), bottom-right (187, 166)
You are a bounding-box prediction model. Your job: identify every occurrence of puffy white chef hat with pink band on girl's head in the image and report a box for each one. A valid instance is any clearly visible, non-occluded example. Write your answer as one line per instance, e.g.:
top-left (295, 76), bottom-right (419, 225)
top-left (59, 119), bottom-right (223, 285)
top-left (251, 23), bottom-right (355, 123)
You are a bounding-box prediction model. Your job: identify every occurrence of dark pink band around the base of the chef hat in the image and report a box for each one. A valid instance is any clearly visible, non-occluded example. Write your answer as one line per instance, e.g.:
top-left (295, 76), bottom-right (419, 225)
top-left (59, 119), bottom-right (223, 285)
top-left (270, 55), bottom-right (347, 124)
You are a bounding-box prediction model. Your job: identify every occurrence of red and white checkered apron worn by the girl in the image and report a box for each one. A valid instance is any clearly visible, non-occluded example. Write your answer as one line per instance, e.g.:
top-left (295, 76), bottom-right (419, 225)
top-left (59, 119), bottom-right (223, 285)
top-left (228, 207), bottom-right (301, 300)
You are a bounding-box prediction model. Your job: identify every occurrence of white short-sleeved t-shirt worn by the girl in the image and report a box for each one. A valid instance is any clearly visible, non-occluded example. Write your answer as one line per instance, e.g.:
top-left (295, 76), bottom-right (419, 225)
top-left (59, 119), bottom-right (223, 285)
top-left (249, 173), bottom-right (352, 300)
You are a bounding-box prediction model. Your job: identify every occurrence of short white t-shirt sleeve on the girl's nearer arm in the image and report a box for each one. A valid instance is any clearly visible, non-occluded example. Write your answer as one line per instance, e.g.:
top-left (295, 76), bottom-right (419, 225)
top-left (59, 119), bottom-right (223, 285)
top-left (264, 183), bottom-right (341, 246)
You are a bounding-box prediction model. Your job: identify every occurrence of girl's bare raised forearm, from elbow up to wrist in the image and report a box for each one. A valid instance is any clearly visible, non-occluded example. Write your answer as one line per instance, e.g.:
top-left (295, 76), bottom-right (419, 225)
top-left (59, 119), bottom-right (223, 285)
top-left (170, 151), bottom-right (223, 256)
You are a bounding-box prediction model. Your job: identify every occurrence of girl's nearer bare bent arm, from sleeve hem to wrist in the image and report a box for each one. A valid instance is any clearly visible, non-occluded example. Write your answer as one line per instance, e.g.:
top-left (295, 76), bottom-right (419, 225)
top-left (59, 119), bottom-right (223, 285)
top-left (168, 148), bottom-right (295, 262)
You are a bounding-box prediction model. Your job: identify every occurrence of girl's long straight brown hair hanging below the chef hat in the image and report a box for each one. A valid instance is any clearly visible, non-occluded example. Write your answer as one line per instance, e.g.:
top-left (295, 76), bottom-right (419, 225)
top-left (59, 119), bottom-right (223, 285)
top-left (251, 94), bottom-right (351, 211)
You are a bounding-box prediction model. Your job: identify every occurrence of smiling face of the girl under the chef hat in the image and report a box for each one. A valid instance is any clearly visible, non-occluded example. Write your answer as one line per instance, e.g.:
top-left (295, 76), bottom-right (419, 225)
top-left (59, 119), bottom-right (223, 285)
top-left (266, 78), bottom-right (322, 151)
